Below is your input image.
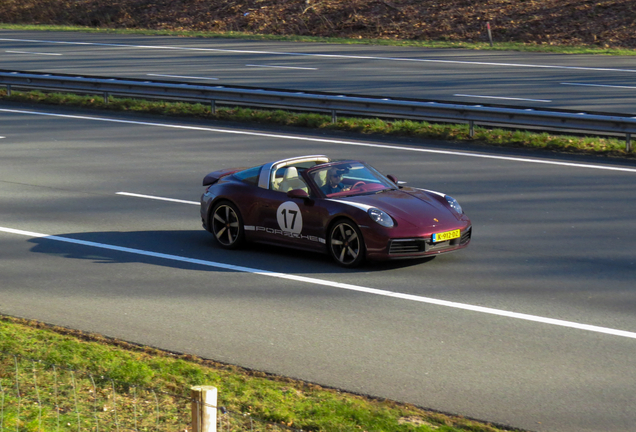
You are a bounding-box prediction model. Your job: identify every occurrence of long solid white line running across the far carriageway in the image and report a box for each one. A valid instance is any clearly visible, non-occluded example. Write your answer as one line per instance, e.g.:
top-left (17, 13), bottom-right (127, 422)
top-left (0, 38), bottom-right (636, 73)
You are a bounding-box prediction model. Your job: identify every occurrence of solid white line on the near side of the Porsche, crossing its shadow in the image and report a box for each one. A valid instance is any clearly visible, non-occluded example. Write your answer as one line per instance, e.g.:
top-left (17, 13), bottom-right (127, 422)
top-left (0, 227), bottom-right (636, 339)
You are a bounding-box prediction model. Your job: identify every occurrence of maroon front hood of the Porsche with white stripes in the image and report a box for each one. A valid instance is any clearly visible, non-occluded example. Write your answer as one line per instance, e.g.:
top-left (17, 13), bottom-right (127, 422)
top-left (338, 188), bottom-right (461, 229)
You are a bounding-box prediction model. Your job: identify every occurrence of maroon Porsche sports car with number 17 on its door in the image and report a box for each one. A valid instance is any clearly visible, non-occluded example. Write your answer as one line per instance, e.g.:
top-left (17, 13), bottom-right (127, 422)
top-left (201, 156), bottom-right (472, 267)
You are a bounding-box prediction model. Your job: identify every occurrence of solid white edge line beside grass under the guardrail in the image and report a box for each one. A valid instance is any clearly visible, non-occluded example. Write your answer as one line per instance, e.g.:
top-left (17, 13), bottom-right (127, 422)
top-left (0, 109), bottom-right (636, 173)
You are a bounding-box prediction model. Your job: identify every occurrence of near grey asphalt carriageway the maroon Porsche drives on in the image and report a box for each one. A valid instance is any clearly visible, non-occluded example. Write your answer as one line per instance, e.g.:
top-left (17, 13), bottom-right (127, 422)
top-left (0, 104), bottom-right (636, 431)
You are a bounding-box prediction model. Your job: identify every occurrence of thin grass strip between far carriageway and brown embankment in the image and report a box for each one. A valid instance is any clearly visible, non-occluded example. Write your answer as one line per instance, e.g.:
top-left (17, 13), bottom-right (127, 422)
top-left (0, 23), bottom-right (636, 56)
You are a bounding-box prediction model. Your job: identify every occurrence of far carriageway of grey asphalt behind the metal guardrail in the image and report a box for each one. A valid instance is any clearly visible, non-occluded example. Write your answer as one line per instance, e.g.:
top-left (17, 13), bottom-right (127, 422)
top-left (0, 30), bottom-right (636, 114)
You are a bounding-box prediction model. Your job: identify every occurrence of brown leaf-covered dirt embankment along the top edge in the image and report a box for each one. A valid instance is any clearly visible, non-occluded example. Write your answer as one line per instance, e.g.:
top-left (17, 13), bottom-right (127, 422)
top-left (0, 0), bottom-right (636, 48)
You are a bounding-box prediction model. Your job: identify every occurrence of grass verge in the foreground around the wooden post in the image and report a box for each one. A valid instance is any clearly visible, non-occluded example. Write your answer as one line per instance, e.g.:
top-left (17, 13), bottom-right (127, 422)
top-left (0, 315), bottom-right (513, 432)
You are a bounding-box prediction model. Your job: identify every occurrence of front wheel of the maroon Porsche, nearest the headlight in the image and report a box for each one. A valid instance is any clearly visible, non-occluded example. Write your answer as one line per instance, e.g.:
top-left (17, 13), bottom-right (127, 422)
top-left (327, 219), bottom-right (364, 268)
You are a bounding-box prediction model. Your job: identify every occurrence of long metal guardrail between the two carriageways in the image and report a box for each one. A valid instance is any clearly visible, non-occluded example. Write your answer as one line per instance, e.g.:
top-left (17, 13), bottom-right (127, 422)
top-left (0, 70), bottom-right (636, 151)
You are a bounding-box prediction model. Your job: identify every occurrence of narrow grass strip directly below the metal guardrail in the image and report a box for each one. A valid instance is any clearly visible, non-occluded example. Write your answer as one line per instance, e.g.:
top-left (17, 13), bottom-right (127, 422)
top-left (0, 90), bottom-right (636, 159)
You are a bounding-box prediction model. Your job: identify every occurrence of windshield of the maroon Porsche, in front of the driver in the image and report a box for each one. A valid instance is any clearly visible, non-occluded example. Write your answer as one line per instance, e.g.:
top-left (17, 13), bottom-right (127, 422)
top-left (309, 162), bottom-right (396, 198)
